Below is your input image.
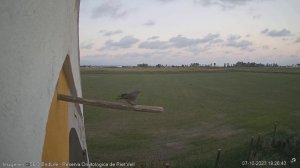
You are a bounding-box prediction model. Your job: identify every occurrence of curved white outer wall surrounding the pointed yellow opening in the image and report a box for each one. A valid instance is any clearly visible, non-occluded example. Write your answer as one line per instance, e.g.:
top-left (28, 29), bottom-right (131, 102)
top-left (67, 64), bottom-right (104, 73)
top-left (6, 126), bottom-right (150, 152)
top-left (0, 0), bottom-right (81, 164)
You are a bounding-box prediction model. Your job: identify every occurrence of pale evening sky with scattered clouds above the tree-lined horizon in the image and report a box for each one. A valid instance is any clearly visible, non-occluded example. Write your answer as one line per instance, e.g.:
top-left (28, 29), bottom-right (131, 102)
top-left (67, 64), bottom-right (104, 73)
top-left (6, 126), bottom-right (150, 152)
top-left (79, 0), bottom-right (300, 66)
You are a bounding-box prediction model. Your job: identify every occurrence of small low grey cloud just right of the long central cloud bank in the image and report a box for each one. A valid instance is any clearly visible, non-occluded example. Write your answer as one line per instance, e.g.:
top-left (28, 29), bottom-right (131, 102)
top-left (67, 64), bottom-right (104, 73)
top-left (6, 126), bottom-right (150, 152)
top-left (226, 35), bottom-right (253, 51)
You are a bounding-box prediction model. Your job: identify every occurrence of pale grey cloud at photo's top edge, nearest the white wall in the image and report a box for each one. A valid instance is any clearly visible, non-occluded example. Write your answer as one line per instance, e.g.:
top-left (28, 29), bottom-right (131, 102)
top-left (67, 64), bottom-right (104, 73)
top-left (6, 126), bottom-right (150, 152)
top-left (92, 0), bottom-right (128, 18)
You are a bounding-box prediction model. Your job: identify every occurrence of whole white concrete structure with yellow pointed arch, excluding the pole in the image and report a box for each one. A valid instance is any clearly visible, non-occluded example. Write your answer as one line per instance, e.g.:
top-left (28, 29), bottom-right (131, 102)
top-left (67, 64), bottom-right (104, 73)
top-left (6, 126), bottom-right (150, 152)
top-left (0, 0), bottom-right (88, 167)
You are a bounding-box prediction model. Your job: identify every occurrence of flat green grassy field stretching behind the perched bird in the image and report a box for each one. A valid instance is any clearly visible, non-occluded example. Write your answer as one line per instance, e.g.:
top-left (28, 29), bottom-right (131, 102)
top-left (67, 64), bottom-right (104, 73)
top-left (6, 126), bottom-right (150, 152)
top-left (81, 69), bottom-right (300, 167)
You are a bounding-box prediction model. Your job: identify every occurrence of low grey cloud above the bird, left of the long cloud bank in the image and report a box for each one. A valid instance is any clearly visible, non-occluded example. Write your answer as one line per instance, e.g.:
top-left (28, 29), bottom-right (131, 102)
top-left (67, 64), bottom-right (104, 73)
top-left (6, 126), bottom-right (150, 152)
top-left (105, 36), bottom-right (139, 48)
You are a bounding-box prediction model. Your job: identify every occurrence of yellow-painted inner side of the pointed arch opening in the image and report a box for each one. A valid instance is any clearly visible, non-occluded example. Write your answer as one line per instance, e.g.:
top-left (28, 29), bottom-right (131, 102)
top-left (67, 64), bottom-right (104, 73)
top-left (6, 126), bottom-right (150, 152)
top-left (42, 70), bottom-right (69, 167)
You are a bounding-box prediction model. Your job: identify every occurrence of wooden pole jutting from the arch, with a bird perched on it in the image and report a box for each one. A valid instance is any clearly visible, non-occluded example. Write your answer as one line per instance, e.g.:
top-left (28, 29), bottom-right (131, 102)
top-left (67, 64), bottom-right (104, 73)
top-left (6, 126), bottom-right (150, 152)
top-left (57, 94), bottom-right (164, 113)
